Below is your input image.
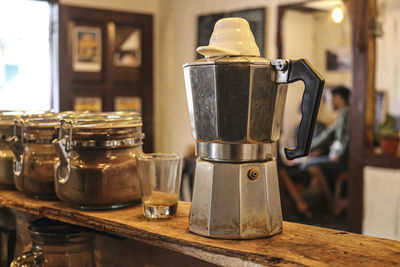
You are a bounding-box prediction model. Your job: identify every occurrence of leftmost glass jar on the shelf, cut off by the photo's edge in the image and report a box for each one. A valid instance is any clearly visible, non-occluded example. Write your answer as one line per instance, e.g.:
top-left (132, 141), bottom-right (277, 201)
top-left (0, 111), bottom-right (22, 189)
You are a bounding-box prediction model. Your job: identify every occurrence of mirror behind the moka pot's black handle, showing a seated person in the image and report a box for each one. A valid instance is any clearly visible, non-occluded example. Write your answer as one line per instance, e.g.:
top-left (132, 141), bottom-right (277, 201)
top-left (277, 0), bottom-right (353, 230)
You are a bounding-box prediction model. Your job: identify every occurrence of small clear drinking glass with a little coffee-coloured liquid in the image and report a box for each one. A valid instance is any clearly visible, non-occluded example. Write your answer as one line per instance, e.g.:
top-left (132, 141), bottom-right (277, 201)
top-left (137, 153), bottom-right (183, 219)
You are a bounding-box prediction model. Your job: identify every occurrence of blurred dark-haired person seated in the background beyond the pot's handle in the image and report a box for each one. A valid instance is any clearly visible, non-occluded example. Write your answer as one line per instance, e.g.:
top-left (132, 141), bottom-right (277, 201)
top-left (300, 86), bottom-right (350, 210)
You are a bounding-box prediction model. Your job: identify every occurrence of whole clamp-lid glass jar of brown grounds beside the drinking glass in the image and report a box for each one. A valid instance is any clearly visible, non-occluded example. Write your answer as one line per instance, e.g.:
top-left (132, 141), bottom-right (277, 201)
top-left (54, 112), bottom-right (144, 209)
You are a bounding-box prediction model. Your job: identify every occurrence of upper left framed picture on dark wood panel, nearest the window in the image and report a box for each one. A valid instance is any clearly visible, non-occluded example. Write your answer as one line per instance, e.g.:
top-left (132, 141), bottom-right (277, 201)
top-left (72, 26), bottom-right (102, 72)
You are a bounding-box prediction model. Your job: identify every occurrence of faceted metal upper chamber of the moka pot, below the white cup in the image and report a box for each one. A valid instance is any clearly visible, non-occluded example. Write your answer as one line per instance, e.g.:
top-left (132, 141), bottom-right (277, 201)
top-left (184, 56), bottom-right (287, 148)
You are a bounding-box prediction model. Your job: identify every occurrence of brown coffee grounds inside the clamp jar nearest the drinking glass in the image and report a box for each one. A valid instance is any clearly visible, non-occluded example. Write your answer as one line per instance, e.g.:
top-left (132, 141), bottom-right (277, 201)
top-left (56, 146), bottom-right (141, 209)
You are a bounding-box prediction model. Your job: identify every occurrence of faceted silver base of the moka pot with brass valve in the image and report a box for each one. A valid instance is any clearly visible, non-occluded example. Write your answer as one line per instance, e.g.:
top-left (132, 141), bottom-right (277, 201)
top-left (189, 143), bottom-right (282, 239)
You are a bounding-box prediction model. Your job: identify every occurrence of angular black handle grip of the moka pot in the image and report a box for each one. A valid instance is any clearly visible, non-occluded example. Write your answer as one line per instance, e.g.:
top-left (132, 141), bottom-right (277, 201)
top-left (285, 59), bottom-right (325, 160)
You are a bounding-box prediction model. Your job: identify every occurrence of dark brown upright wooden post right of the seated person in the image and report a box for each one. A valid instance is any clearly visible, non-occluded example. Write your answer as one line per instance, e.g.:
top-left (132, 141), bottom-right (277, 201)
top-left (345, 0), bottom-right (376, 233)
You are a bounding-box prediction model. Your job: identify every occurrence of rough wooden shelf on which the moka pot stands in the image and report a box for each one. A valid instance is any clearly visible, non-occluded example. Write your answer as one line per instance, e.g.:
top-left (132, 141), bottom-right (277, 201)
top-left (0, 190), bottom-right (400, 266)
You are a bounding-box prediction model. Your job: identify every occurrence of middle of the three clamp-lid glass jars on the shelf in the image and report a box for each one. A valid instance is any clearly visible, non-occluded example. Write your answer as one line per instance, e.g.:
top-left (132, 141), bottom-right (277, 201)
top-left (8, 112), bottom-right (59, 199)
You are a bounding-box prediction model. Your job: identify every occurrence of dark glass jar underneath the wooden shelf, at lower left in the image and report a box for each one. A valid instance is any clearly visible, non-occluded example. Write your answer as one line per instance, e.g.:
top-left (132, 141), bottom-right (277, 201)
top-left (10, 218), bottom-right (96, 267)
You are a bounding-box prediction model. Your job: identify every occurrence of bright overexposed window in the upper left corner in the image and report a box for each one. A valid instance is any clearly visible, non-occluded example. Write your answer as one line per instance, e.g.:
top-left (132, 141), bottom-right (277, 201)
top-left (0, 0), bottom-right (51, 110)
